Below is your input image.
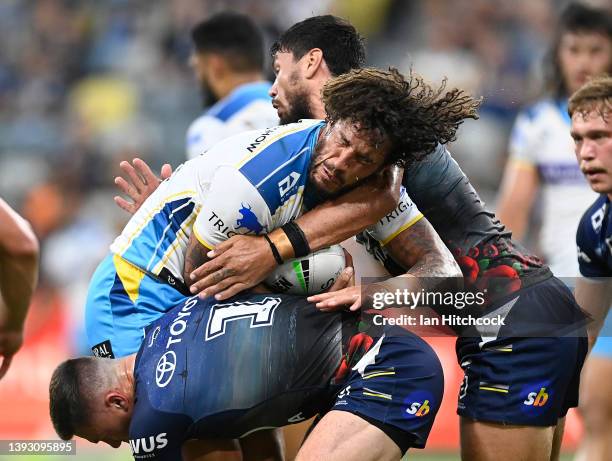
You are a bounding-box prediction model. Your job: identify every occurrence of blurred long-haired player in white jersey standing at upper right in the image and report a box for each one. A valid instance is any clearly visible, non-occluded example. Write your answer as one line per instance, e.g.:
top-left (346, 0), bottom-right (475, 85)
top-left (498, 4), bottom-right (612, 277)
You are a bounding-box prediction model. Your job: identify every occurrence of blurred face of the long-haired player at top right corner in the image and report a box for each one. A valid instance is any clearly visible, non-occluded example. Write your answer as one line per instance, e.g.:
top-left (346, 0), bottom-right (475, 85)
top-left (559, 32), bottom-right (612, 94)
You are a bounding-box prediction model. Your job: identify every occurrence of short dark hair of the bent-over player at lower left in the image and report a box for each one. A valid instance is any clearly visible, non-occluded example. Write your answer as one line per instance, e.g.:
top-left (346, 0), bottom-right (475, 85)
top-left (49, 357), bottom-right (109, 440)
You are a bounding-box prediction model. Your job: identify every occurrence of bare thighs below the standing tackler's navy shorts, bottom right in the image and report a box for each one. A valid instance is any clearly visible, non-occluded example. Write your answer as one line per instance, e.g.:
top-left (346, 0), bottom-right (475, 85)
top-left (460, 417), bottom-right (555, 461)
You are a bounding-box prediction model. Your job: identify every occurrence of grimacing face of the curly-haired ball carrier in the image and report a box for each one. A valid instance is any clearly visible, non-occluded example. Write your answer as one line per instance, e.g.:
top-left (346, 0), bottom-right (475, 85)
top-left (308, 120), bottom-right (390, 198)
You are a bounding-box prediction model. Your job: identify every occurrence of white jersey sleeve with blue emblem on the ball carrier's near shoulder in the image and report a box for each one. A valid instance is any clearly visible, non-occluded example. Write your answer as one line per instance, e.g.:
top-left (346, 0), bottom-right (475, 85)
top-left (193, 166), bottom-right (272, 249)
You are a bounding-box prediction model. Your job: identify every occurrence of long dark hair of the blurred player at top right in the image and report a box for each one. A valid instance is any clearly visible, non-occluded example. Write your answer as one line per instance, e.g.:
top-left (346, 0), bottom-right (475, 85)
top-left (546, 3), bottom-right (612, 98)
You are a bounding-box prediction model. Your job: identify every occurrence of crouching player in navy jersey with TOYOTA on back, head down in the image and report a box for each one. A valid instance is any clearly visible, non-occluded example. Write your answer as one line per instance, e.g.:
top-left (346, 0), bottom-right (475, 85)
top-left (50, 294), bottom-right (444, 461)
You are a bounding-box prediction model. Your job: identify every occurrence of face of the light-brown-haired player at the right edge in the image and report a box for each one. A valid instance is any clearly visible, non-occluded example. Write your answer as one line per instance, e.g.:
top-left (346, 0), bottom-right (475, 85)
top-left (571, 111), bottom-right (612, 196)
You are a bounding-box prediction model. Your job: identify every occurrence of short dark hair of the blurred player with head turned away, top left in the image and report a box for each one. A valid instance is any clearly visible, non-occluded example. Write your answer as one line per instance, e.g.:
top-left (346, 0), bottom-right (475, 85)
top-left (191, 11), bottom-right (264, 72)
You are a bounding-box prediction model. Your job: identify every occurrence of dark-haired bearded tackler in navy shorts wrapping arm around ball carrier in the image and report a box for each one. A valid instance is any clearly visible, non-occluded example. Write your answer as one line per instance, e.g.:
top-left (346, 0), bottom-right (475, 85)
top-left (190, 16), bottom-right (586, 461)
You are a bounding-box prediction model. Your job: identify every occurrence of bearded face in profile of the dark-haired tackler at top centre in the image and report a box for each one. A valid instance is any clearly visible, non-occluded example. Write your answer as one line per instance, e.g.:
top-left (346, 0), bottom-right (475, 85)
top-left (270, 52), bottom-right (313, 125)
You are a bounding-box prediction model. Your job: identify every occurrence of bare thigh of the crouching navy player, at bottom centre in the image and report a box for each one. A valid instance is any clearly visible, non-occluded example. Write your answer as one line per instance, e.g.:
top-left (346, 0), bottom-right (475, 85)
top-left (295, 411), bottom-right (402, 461)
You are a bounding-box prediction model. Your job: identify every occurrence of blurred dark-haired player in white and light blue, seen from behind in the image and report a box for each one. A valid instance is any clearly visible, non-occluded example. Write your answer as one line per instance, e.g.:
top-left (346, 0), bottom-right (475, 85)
top-left (182, 12), bottom-right (278, 158)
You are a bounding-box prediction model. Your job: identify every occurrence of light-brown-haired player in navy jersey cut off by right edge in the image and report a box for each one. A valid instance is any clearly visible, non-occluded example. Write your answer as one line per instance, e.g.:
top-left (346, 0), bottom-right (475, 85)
top-left (569, 77), bottom-right (612, 461)
